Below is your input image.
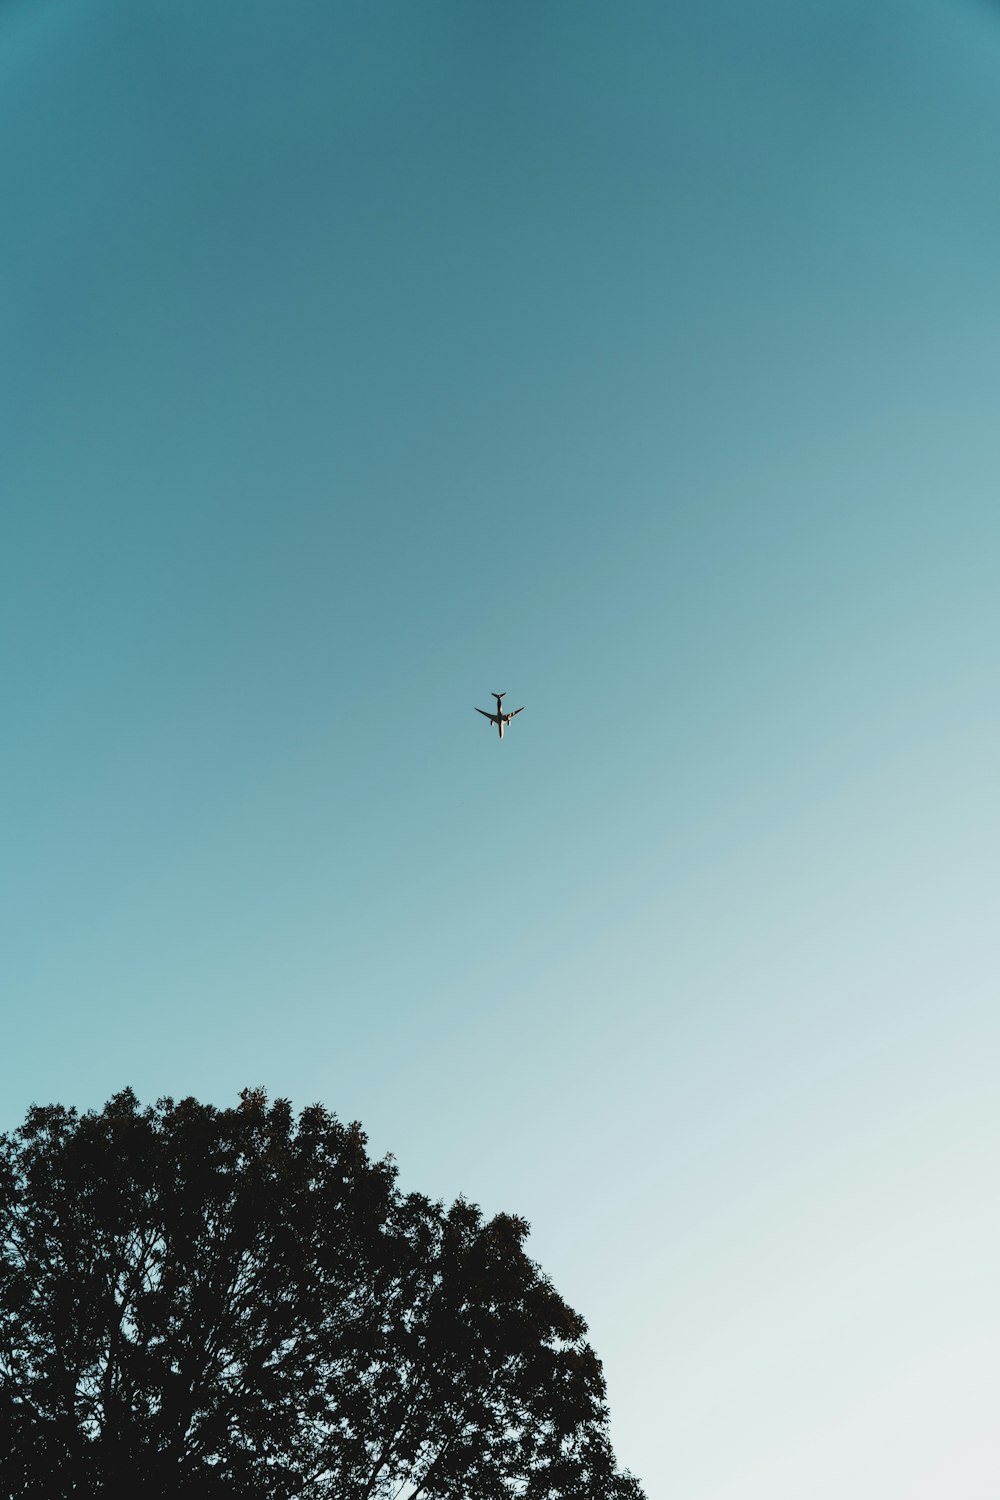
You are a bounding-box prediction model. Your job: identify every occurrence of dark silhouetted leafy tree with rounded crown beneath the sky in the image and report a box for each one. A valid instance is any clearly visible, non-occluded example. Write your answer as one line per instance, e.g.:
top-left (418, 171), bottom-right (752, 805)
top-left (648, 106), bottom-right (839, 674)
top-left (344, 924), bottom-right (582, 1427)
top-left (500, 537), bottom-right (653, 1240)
top-left (0, 1091), bottom-right (642, 1500)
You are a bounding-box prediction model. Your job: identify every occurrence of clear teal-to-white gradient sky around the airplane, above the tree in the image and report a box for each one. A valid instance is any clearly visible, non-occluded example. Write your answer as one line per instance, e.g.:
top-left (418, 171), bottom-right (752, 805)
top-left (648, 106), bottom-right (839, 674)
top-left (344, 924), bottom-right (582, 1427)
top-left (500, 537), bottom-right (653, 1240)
top-left (0, 0), bottom-right (1000, 1500)
